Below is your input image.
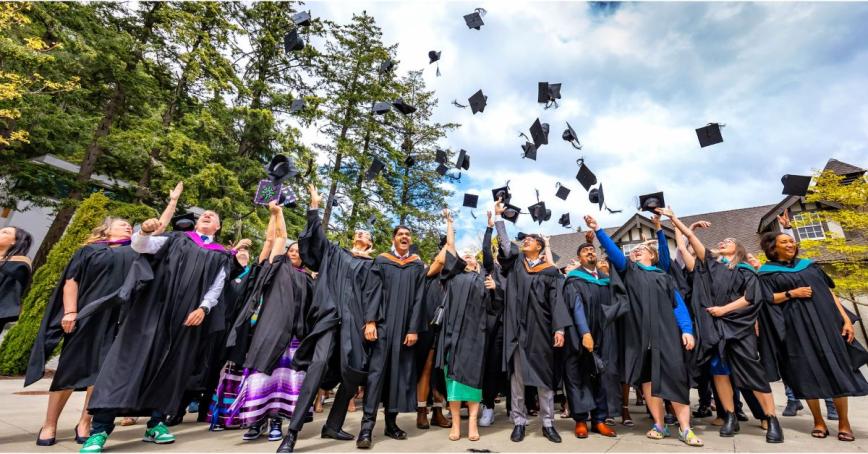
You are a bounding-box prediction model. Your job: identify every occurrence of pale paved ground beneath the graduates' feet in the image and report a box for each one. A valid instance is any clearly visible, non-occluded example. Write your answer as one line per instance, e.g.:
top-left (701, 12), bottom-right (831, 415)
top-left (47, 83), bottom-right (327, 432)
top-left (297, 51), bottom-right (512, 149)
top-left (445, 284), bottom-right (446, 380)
top-left (0, 378), bottom-right (868, 453)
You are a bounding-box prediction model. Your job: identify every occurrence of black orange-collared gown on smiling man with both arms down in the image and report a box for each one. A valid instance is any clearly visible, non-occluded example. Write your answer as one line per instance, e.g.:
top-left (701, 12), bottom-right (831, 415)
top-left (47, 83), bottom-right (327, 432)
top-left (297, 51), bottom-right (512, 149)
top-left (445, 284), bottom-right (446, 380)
top-left (365, 252), bottom-right (428, 414)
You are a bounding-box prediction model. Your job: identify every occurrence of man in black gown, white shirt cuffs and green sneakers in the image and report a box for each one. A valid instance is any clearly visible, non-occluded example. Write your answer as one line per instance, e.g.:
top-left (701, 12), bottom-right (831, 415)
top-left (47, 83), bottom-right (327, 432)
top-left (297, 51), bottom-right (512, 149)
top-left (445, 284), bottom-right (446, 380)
top-left (79, 207), bottom-right (233, 453)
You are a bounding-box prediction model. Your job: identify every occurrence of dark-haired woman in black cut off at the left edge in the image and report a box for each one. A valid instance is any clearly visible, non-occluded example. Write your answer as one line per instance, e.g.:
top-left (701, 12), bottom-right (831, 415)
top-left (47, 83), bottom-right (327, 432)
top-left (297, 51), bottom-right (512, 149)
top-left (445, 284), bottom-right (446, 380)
top-left (0, 227), bottom-right (33, 332)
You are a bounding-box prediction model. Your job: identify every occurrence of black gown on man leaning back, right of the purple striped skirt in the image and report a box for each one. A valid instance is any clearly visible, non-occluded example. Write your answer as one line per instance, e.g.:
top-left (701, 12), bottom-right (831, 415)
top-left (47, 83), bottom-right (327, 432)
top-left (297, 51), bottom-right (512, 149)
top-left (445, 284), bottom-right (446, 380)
top-left (292, 210), bottom-right (382, 387)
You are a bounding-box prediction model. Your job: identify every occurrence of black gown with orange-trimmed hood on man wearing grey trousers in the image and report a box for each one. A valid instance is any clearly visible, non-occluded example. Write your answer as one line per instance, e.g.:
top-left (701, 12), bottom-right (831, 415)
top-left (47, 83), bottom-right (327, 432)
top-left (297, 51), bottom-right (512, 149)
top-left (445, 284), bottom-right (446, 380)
top-left (498, 244), bottom-right (573, 390)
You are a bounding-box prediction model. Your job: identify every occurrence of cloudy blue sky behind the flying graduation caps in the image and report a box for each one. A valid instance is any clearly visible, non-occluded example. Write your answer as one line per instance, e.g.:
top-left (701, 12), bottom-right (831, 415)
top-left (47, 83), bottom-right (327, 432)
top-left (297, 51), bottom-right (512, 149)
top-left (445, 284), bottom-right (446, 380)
top-left (305, 1), bottom-right (868, 245)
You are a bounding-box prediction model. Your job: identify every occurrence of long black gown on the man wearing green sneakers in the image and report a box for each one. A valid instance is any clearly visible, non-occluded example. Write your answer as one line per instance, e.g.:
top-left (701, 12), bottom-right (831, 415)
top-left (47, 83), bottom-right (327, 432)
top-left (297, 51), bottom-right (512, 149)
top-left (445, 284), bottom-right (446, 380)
top-left (85, 232), bottom-right (232, 416)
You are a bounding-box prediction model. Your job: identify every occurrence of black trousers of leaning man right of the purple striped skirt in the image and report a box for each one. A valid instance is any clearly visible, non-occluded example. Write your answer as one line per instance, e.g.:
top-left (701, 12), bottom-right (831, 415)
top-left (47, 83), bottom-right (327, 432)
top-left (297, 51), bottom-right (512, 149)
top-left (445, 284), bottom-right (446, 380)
top-left (289, 327), bottom-right (357, 432)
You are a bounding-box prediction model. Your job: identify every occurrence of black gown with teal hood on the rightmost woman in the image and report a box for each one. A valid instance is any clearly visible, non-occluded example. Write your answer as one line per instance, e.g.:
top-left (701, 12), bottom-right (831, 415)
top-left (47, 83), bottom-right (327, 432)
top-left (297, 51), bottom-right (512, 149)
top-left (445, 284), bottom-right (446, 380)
top-left (759, 258), bottom-right (868, 399)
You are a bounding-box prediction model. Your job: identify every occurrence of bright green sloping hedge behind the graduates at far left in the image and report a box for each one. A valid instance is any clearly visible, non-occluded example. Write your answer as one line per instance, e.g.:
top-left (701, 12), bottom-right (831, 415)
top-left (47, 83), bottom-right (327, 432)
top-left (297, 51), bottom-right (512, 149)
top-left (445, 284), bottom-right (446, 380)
top-left (0, 193), bottom-right (156, 375)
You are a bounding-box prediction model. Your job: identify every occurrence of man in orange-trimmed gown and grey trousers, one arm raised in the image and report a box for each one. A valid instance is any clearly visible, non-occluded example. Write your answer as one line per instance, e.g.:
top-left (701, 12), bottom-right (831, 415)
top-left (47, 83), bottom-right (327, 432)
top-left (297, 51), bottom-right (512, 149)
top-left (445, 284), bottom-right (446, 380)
top-left (494, 201), bottom-right (572, 443)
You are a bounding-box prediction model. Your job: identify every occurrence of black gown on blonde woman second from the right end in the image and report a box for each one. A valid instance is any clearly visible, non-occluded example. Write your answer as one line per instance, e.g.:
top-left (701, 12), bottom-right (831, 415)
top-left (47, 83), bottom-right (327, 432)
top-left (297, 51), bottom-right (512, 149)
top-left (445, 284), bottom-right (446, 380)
top-left (691, 251), bottom-right (771, 392)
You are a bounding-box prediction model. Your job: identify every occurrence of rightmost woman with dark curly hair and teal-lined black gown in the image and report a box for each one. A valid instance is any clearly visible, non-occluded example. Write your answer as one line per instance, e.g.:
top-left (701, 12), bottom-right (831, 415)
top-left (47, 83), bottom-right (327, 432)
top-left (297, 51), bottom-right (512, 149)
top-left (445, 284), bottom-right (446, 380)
top-left (759, 219), bottom-right (868, 441)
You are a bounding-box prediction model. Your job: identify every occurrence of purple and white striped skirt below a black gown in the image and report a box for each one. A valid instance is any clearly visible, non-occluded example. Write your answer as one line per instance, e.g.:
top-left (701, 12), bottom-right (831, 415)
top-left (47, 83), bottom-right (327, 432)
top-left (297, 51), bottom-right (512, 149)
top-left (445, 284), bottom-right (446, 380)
top-left (224, 338), bottom-right (310, 427)
